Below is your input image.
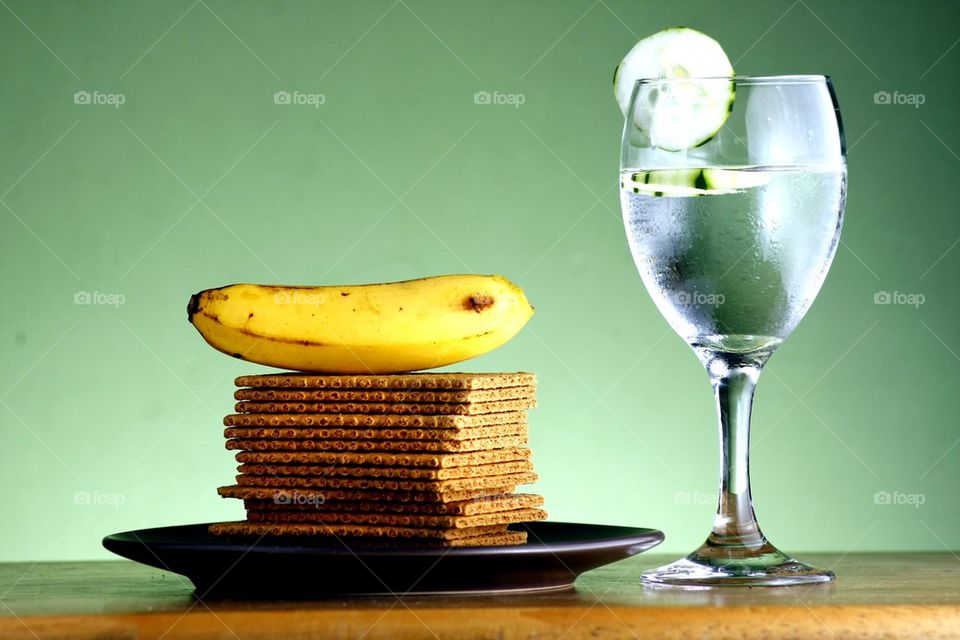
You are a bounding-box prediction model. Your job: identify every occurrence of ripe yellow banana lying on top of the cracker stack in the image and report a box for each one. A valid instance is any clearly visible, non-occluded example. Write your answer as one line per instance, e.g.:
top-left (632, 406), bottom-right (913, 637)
top-left (187, 275), bottom-right (533, 373)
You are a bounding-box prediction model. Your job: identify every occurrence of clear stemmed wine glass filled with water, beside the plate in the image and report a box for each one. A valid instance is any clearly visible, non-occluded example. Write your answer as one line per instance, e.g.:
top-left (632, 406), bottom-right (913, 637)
top-left (620, 76), bottom-right (846, 586)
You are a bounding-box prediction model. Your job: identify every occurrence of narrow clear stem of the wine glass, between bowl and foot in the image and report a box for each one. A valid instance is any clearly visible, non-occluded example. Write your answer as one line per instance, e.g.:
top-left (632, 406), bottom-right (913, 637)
top-left (706, 353), bottom-right (767, 554)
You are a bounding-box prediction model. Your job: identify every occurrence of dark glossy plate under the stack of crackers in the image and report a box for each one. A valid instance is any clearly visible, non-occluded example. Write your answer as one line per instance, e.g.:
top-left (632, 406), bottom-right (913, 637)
top-left (103, 522), bottom-right (663, 598)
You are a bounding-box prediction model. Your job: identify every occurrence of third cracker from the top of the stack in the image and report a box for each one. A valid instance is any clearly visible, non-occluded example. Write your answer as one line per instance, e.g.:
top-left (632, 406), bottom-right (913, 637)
top-left (234, 398), bottom-right (537, 416)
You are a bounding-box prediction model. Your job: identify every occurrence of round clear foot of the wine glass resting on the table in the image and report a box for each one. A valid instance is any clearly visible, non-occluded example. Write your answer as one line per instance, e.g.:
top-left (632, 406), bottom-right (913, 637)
top-left (641, 543), bottom-right (836, 587)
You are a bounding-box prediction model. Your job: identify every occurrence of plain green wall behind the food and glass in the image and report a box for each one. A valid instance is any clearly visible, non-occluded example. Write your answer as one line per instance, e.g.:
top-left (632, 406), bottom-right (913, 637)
top-left (0, 0), bottom-right (960, 560)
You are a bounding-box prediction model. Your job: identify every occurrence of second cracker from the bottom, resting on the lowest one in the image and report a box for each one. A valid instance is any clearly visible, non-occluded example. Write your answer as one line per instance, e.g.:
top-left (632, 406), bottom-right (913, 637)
top-left (247, 509), bottom-right (547, 529)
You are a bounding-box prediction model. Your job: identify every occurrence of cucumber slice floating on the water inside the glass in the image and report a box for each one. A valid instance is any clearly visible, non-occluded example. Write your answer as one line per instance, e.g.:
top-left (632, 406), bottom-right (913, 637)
top-left (620, 169), bottom-right (770, 198)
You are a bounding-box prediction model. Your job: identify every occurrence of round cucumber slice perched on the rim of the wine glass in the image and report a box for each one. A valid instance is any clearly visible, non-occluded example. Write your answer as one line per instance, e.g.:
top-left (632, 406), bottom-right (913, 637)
top-left (613, 27), bottom-right (734, 151)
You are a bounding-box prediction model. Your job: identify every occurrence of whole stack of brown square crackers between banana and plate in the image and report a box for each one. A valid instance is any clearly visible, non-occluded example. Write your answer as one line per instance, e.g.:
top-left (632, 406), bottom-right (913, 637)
top-left (210, 373), bottom-right (546, 546)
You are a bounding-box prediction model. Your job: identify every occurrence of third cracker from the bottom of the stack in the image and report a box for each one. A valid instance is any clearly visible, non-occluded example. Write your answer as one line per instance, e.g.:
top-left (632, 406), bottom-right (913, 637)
top-left (243, 493), bottom-right (543, 516)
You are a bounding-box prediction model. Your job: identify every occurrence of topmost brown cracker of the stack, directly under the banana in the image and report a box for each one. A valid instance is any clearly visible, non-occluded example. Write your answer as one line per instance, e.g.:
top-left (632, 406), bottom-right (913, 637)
top-left (234, 372), bottom-right (537, 390)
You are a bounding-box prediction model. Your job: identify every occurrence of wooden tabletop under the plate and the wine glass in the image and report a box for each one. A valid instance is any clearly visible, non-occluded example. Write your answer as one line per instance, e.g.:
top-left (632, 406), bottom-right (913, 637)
top-left (0, 553), bottom-right (960, 640)
